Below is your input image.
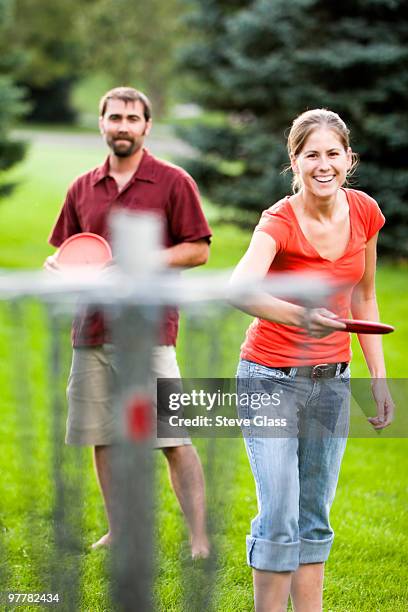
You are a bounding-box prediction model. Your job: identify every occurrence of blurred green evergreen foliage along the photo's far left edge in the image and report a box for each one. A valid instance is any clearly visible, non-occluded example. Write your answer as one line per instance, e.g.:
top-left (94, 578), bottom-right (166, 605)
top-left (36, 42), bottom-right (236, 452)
top-left (0, 0), bottom-right (25, 197)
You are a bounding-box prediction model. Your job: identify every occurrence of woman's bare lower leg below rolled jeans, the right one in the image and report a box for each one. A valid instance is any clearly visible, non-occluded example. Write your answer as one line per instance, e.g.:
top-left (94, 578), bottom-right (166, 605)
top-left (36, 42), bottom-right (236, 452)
top-left (290, 563), bottom-right (324, 612)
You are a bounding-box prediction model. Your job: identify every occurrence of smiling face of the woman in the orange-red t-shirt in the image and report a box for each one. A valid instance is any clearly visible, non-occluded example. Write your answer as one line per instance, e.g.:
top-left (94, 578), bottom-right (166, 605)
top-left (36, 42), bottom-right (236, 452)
top-left (291, 127), bottom-right (352, 199)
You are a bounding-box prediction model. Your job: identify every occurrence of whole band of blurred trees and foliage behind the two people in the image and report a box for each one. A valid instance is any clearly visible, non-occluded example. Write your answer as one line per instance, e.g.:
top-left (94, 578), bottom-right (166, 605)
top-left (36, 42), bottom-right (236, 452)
top-left (0, 0), bottom-right (408, 251)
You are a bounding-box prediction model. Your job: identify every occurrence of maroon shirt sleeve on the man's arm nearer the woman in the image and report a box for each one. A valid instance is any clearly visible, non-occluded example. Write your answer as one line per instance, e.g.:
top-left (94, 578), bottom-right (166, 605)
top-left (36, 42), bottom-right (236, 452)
top-left (167, 173), bottom-right (211, 244)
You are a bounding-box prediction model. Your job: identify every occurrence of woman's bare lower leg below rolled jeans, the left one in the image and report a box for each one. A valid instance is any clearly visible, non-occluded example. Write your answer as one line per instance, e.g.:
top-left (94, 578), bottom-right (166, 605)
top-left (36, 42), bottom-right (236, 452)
top-left (253, 569), bottom-right (293, 612)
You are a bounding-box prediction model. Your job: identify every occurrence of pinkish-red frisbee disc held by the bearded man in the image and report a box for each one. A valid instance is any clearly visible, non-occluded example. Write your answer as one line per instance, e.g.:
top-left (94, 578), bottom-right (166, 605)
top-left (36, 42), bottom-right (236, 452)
top-left (57, 232), bottom-right (112, 266)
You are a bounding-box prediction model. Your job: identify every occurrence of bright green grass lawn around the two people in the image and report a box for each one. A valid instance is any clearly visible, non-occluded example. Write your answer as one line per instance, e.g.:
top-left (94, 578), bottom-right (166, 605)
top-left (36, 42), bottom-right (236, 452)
top-left (0, 135), bottom-right (408, 612)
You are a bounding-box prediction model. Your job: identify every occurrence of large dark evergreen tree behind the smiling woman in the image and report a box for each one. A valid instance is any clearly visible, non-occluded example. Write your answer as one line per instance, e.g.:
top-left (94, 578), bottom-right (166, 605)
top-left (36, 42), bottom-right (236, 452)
top-left (181, 0), bottom-right (408, 256)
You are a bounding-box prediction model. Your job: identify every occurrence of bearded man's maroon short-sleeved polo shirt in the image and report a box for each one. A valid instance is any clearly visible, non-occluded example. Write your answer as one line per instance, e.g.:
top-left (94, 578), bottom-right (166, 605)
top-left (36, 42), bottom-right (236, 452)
top-left (49, 149), bottom-right (211, 347)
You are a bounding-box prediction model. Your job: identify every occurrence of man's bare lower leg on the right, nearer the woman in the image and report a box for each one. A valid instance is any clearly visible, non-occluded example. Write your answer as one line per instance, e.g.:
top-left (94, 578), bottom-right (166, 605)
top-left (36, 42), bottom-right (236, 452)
top-left (163, 444), bottom-right (210, 559)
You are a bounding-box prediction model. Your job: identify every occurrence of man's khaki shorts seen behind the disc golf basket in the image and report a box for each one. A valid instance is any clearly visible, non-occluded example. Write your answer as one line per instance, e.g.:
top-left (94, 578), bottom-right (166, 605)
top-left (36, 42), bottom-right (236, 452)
top-left (65, 344), bottom-right (191, 448)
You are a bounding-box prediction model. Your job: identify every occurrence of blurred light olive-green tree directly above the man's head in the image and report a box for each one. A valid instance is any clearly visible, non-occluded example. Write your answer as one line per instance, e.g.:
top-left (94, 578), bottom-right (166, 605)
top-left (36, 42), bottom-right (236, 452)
top-left (79, 0), bottom-right (181, 116)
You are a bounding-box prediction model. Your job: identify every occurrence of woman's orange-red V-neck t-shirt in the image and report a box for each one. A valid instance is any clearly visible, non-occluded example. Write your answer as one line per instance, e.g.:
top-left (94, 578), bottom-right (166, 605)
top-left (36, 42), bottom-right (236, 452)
top-left (241, 189), bottom-right (385, 367)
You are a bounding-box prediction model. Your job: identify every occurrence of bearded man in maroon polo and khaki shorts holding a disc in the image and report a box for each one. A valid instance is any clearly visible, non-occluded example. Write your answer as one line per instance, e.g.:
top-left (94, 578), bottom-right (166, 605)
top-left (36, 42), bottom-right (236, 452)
top-left (45, 87), bottom-right (211, 558)
